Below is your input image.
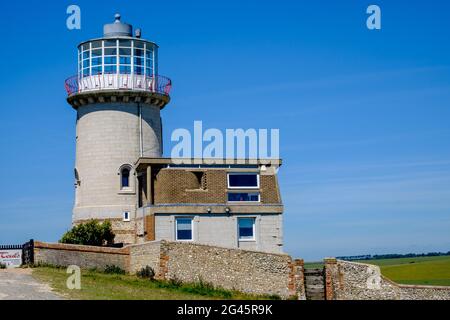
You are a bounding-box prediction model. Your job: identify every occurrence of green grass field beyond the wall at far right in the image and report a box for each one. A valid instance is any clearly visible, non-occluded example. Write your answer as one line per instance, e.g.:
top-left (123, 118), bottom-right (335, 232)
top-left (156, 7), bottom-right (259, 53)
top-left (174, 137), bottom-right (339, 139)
top-left (360, 256), bottom-right (450, 286)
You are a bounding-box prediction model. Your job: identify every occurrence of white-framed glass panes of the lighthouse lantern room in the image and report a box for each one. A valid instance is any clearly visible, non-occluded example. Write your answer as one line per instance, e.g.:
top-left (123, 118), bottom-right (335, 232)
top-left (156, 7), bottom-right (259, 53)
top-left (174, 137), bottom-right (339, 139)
top-left (78, 39), bottom-right (156, 78)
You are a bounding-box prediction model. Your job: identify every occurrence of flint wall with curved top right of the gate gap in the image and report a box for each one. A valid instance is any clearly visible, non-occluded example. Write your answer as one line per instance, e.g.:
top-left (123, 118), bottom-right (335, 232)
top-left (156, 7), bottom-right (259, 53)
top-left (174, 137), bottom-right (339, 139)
top-left (325, 259), bottom-right (450, 300)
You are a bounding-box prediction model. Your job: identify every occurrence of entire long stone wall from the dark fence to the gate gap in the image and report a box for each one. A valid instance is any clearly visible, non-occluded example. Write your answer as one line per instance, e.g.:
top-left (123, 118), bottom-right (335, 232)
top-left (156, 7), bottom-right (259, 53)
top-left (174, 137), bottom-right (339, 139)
top-left (35, 241), bottom-right (305, 299)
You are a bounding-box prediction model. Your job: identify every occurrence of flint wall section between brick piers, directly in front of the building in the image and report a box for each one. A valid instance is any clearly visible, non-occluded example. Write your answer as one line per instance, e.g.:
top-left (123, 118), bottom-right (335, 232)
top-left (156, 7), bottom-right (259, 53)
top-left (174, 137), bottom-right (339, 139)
top-left (159, 241), bottom-right (303, 298)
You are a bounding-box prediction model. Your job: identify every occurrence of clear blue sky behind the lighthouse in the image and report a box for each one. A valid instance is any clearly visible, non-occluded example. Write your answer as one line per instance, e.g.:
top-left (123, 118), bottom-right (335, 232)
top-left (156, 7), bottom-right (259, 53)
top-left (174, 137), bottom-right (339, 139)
top-left (0, 0), bottom-right (450, 260)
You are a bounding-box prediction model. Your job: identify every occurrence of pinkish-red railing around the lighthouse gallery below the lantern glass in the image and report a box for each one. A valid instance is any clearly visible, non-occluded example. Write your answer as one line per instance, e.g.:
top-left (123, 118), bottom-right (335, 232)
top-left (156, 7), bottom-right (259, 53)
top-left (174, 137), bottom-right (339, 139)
top-left (65, 74), bottom-right (172, 96)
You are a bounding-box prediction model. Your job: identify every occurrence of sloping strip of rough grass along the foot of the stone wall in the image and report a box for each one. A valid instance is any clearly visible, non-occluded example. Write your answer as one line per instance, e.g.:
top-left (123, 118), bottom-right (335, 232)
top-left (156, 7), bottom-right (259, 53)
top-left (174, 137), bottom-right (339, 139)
top-left (33, 267), bottom-right (279, 300)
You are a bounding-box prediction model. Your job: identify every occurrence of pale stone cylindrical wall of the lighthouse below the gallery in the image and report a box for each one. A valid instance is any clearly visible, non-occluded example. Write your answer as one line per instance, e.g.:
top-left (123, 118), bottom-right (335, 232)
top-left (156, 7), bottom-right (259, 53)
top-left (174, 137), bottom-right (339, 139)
top-left (73, 101), bottom-right (162, 228)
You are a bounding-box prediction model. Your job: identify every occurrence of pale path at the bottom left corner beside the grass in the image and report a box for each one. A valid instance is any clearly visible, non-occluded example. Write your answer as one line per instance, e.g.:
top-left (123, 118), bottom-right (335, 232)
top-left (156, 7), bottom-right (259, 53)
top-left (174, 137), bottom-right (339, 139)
top-left (0, 269), bottom-right (63, 300)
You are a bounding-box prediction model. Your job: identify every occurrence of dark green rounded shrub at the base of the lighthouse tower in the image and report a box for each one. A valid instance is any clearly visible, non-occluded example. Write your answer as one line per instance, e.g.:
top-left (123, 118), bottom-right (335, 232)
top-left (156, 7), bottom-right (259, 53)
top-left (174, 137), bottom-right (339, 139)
top-left (59, 220), bottom-right (115, 247)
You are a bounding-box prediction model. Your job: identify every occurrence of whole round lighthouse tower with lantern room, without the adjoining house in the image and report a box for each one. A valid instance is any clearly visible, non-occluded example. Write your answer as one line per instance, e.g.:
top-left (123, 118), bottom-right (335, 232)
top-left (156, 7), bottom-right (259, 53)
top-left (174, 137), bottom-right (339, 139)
top-left (66, 14), bottom-right (171, 243)
